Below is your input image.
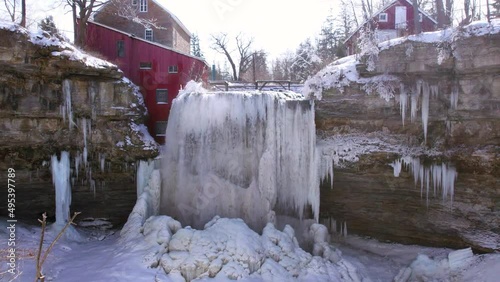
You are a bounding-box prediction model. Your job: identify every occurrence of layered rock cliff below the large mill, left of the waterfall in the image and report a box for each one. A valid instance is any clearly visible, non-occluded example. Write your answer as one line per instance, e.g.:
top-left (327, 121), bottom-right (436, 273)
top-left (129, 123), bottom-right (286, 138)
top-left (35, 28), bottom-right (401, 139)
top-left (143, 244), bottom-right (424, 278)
top-left (0, 26), bottom-right (157, 224)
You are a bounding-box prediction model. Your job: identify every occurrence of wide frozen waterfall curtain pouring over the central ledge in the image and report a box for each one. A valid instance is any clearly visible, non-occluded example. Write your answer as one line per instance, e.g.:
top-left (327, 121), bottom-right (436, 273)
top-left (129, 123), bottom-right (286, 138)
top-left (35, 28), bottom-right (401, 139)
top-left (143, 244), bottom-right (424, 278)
top-left (161, 91), bottom-right (319, 230)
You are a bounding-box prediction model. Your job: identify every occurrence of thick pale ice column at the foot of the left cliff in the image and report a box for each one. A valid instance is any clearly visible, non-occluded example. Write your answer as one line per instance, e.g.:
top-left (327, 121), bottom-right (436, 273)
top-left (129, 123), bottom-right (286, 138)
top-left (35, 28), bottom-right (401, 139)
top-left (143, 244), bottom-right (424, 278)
top-left (51, 152), bottom-right (71, 225)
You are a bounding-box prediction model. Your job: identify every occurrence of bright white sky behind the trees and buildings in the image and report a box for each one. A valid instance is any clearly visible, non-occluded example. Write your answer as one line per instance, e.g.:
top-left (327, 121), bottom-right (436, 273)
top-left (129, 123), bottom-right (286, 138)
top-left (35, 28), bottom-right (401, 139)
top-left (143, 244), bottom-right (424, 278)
top-left (0, 0), bottom-right (337, 64)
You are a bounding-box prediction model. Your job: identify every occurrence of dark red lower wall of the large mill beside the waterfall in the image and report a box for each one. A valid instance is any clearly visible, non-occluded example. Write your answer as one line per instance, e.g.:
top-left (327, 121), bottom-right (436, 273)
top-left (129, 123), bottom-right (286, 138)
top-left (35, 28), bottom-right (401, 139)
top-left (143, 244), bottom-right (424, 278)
top-left (87, 22), bottom-right (209, 143)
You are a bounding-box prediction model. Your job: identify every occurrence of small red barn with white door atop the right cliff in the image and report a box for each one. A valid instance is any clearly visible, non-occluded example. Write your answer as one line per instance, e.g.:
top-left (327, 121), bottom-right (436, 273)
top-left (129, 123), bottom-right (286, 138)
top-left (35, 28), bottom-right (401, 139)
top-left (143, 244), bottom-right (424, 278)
top-left (344, 0), bottom-right (437, 55)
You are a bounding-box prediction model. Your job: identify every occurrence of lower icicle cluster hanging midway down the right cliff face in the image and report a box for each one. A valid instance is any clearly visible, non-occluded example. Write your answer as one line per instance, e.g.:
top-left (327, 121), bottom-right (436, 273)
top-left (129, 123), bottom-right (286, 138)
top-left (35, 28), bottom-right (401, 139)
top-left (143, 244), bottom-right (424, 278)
top-left (390, 157), bottom-right (458, 203)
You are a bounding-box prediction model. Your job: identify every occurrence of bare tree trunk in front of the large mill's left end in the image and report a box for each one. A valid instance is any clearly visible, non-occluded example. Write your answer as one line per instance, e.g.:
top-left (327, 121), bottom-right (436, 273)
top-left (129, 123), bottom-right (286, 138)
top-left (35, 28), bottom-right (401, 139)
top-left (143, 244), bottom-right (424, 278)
top-left (66, 0), bottom-right (107, 47)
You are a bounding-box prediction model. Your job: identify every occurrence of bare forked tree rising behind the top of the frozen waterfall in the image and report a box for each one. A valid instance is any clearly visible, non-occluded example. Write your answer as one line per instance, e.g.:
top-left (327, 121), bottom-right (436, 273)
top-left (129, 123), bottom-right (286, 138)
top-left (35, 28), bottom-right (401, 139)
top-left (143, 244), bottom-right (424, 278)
top-left (211, 33), bottom-right (253, 81)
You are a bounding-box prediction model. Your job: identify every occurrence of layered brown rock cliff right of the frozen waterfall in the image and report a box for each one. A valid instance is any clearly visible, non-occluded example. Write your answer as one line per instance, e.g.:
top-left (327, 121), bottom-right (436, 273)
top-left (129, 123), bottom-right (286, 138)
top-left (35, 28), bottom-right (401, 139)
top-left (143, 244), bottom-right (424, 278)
top-left (306, 23), bottom-right (500, 251)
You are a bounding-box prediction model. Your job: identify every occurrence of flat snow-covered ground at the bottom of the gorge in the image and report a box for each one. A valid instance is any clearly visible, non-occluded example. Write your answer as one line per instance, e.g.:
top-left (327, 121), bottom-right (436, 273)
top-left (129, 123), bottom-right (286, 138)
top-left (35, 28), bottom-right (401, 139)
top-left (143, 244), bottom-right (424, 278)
top-left (0, 218), bottom-right (500, 282)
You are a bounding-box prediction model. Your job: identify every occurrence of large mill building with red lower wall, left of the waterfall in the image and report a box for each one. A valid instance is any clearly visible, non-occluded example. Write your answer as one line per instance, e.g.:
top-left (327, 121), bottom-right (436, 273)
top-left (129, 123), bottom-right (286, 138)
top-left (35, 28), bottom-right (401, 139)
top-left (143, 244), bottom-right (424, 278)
top-left (86, 0), bottom-right (209, 143)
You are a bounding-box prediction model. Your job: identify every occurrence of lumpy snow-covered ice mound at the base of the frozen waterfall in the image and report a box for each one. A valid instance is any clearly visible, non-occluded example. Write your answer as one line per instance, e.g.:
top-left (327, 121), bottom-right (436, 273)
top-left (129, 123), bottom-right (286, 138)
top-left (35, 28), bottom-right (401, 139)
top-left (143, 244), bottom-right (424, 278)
top-left (131, 216), bottom-right (361, 281)
